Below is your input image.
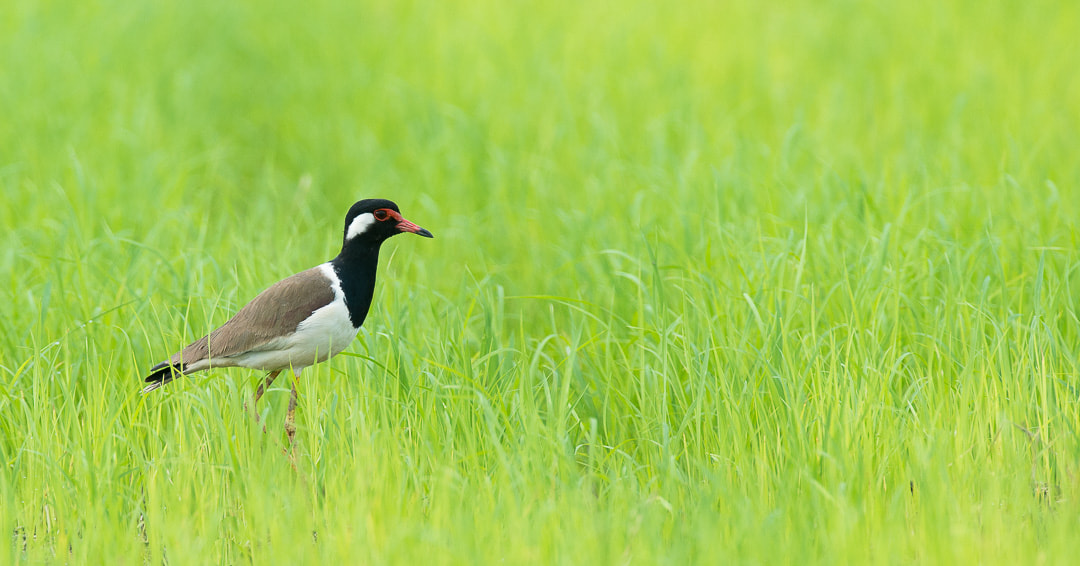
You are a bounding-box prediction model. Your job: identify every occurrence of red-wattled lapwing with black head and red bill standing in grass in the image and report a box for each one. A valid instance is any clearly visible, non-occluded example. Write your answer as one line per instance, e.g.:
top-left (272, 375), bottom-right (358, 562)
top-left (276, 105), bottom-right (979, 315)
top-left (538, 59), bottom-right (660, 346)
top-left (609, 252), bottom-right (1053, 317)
top-left (143, 199), bottom-right (434, 443)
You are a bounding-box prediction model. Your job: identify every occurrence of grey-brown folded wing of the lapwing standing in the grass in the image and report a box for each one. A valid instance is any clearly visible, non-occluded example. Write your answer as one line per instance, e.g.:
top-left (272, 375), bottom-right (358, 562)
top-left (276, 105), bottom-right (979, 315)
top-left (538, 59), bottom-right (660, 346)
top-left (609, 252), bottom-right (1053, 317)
top-left (168, 267), bottom-right (334, 365)
